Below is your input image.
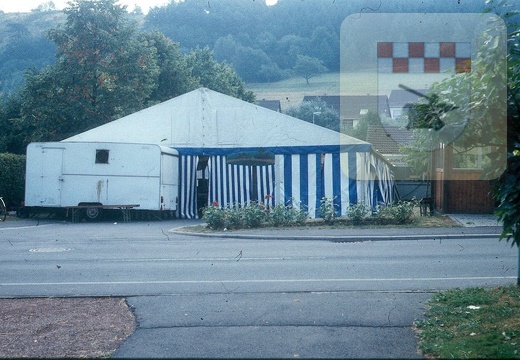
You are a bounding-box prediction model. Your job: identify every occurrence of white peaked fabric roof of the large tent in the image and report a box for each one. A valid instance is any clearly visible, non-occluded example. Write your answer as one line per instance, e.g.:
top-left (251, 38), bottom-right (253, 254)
top-left (64, 88), bottom-right (371, 155)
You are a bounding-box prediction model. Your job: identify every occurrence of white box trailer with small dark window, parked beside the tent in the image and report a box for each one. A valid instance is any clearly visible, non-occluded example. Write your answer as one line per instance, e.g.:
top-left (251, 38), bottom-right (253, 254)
top-left (25, 142), bottom-right (179, 220)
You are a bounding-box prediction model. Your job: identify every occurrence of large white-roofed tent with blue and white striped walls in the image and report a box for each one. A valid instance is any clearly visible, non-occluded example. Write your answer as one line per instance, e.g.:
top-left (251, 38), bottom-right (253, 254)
top-left (63, 88), bottom-right (392, 218)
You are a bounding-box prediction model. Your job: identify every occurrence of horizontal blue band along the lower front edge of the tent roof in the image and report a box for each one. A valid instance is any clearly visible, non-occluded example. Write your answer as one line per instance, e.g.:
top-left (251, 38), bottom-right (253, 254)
top-left (172, 143), bottom-right (372, 156)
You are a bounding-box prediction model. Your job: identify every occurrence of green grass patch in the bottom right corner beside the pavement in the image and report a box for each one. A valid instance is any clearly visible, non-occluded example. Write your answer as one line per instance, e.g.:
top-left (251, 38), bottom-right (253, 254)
top-left (415, 286), bottom-right (520, 359)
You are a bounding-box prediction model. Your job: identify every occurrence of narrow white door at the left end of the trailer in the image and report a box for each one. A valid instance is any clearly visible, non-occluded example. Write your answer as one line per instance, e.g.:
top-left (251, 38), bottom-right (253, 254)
top-left (40, 148), bottom-right (63, 206)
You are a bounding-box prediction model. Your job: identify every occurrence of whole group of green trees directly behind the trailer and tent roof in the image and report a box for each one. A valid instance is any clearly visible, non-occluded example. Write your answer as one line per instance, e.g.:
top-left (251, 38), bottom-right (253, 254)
top-left (0, 0), bottom-right (254, 153)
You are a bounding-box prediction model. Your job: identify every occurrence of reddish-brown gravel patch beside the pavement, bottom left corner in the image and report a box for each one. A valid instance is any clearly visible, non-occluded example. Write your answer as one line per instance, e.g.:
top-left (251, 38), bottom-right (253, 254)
top-left (0, 298), bottom-right (135, 358)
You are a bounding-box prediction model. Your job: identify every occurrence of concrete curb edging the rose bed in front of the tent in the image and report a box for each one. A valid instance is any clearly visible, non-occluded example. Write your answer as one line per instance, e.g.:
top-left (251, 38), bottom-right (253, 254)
top-left (169, 226), bottom-right (500, 242)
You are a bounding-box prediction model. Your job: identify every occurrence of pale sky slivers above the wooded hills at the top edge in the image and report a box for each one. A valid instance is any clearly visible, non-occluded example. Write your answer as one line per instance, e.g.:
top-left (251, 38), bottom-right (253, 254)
top-left (0, 0), bottom-right (277, 13)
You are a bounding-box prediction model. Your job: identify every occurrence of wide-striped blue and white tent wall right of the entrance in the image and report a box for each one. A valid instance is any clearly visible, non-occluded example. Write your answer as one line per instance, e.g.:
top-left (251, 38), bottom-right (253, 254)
top-left (275, 152), bottom-right (392, 217)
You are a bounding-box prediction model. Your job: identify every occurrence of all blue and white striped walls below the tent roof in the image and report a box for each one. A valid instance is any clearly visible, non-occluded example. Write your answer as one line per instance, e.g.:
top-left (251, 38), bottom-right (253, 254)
top-left (179, 149), bottom-right (393, 218)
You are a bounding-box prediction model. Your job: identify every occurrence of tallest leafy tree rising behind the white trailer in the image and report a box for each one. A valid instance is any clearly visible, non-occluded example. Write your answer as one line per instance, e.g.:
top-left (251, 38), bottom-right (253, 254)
top-left (22, 0), bottom-right (159, 140)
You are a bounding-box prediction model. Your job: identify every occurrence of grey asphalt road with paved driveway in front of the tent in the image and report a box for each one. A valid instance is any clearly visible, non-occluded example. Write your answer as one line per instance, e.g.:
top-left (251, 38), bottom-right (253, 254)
top-left (0, 220), bottom-right (517, 358)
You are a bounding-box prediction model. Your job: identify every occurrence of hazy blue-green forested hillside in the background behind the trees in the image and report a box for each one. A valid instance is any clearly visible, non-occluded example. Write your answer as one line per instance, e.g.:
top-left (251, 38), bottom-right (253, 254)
top-left (0, 0), bottom-right (485, 96)
